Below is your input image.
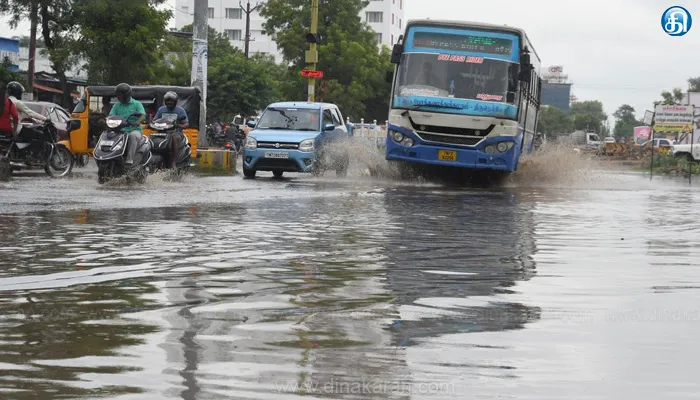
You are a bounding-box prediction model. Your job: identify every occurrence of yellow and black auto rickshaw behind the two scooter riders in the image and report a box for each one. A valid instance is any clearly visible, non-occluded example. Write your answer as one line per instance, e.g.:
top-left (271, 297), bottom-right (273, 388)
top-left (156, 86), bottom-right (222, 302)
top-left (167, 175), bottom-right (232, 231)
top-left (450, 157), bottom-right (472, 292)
top-left (66, 86), bottom-right (202, 158)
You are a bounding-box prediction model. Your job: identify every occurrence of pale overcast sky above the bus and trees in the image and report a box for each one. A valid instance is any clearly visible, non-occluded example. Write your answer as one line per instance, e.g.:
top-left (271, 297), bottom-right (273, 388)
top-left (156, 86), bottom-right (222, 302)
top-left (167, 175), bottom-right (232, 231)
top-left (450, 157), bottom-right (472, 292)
top-left (0, 0), bottom-right (700, 125)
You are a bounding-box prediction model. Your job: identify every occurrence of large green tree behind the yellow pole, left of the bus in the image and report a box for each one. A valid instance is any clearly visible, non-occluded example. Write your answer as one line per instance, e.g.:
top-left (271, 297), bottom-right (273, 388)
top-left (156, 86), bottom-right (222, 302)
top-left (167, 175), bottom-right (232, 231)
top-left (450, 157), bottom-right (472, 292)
top-left (260, 0), bottom-right (392, 120)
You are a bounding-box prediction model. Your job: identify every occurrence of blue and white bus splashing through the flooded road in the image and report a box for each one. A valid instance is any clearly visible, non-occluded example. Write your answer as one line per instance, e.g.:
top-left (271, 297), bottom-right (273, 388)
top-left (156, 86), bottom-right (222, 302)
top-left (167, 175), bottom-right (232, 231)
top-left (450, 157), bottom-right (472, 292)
top-left (386, 20), bottom-right (542, 176)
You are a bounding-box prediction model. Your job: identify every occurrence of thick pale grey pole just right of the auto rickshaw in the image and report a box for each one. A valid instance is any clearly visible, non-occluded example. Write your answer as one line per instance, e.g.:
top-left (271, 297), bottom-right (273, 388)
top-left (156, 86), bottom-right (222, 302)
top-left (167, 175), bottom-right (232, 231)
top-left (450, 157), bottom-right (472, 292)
top-left (191, 0), bottom-right (209, 147)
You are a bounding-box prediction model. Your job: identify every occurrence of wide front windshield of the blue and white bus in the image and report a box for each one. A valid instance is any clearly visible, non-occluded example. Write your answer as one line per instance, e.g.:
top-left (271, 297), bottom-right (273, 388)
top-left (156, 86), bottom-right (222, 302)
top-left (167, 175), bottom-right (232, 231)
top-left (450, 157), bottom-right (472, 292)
top-left (394, 53), bottom-right (517, 108)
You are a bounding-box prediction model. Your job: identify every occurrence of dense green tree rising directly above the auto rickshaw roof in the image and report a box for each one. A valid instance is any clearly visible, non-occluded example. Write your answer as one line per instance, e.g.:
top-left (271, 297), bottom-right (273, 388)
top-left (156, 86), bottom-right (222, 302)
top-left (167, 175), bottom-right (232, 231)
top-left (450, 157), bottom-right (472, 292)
top-left (73, 0), bottom-right (172, 85)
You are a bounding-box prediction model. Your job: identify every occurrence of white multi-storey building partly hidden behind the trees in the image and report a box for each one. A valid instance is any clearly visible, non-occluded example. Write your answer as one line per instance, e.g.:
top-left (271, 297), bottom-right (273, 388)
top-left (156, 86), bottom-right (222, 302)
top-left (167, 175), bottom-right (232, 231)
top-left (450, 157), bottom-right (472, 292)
top-left (175, 0), bottom-right (405, 62)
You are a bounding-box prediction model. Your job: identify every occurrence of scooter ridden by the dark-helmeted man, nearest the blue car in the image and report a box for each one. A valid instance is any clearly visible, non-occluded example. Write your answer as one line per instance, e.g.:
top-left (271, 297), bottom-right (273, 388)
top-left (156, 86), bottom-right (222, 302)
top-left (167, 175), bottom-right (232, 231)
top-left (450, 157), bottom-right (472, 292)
top-left (148, 117), bottom-right (192, 175)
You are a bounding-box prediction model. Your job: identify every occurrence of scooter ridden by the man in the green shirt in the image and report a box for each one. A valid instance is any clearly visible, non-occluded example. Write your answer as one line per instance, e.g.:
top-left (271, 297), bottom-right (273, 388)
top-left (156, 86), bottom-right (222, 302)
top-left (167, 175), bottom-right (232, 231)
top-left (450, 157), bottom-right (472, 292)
top-left (93, 113), bottom-right (152, 184)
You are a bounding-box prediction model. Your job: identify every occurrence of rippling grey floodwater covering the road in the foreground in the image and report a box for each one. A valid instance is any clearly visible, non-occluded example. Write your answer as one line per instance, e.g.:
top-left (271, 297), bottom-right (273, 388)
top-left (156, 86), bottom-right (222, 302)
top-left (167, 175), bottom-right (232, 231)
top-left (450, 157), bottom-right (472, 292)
top-left (0, 148), bottom-right (700, 400)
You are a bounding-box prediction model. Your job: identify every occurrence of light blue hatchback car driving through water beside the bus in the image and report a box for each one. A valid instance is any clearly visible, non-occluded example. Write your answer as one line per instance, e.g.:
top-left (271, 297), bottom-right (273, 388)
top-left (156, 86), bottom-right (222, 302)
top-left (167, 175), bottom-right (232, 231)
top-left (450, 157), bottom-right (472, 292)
top-left (243, 102), bottom-right (351, 179)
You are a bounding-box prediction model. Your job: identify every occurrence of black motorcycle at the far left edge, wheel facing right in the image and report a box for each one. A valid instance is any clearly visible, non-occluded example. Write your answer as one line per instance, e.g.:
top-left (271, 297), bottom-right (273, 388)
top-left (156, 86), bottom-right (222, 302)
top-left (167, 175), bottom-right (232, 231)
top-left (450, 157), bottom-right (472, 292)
top-left (0, 119), bottom-right (75, 179)
